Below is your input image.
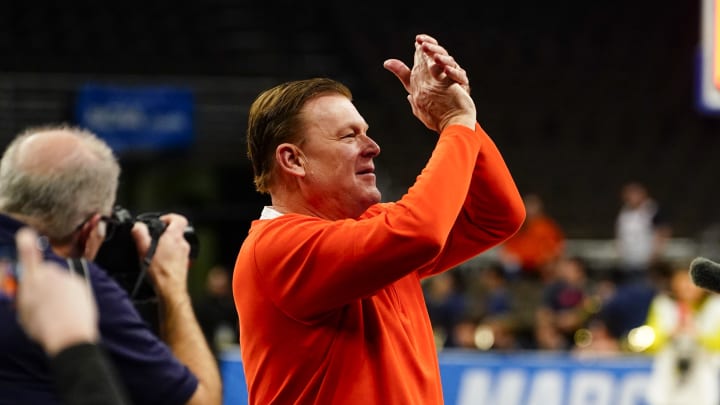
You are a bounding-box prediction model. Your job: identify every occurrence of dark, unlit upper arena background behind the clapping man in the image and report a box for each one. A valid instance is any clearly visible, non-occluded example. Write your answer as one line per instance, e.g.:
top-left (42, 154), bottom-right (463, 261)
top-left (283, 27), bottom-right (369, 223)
top-left (0, 0), bottom-right (720, 290)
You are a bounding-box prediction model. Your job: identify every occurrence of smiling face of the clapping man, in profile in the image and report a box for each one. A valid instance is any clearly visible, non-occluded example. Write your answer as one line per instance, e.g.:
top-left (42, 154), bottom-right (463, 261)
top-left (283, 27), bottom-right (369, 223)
top-left (300, 94), bottom-right (380, 219)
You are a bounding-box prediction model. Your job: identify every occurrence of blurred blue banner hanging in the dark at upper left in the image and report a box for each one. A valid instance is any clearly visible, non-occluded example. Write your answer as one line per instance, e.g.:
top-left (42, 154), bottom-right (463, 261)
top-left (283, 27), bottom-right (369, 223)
top-left (75, 84), bottom-right (194, 153)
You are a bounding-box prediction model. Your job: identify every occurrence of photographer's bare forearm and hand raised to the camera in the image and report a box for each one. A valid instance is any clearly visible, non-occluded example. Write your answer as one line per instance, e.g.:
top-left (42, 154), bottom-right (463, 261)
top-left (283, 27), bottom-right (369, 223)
top-left (132, 214), bottom-right (222, 404)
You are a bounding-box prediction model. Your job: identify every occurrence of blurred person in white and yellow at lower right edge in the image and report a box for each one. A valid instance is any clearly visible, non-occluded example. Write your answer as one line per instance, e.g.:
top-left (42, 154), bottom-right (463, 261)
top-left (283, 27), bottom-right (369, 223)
top-left (644, 264), bottom-right (720, 405)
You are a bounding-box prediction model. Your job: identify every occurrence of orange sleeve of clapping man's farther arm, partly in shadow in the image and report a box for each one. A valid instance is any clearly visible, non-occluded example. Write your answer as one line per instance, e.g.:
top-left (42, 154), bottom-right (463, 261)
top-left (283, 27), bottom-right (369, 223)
top-left (422, 125), bottom-right (525, 277)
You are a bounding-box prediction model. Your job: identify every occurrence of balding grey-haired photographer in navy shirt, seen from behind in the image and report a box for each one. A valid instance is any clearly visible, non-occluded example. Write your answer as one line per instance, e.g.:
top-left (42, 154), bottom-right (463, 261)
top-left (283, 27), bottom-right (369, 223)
top-left (0, 127), bottom-right (221, 404)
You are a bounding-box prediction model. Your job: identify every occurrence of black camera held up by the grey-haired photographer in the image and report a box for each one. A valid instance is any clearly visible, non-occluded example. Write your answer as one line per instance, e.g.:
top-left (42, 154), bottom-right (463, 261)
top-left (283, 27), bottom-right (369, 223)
top-left (95, 206), bottom-right (198, 303)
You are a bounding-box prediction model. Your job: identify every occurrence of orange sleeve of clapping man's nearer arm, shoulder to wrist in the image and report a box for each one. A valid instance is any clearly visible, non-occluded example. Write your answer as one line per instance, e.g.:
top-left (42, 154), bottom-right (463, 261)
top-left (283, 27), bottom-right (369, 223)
top-left (246, 125), bottom-right (485, 319)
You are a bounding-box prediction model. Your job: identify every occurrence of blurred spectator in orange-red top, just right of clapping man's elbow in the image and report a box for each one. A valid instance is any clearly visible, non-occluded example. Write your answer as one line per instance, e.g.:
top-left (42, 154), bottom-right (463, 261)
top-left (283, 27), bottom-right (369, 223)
top-left (499, 194), bottom-right (565, 278)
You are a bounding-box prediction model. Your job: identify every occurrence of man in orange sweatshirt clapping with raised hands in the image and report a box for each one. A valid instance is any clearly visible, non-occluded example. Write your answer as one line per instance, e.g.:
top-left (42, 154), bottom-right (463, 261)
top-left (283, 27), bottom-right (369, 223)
top-left (233, 35), bottom-right (525, 405)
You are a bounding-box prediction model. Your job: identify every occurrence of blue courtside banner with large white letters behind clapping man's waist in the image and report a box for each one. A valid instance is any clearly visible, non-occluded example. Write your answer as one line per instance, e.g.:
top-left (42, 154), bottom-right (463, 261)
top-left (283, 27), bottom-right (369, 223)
top-left (220, 351), bottom-right (652, 405)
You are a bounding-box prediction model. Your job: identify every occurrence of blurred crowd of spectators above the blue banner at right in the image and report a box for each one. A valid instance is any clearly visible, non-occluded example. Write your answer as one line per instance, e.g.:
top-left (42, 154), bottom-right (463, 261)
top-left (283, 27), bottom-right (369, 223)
top-left (424, 182), bottom-right (720, 353)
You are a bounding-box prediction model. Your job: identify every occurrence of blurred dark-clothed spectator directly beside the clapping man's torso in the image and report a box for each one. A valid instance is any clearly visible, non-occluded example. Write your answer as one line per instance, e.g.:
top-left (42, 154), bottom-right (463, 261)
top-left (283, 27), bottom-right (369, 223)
top-left (424, 270), bottom-right (467, 349)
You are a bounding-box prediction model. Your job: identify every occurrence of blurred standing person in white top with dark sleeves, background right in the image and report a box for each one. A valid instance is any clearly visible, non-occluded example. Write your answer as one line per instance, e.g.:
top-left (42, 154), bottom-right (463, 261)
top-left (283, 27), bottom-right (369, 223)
top-left (615, 182), bottom-right (672, 284)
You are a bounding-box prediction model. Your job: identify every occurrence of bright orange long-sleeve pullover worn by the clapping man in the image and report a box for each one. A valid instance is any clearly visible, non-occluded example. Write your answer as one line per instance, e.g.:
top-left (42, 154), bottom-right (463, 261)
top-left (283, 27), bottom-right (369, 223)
top-left (233, 125), bottom-right (525, 405)
